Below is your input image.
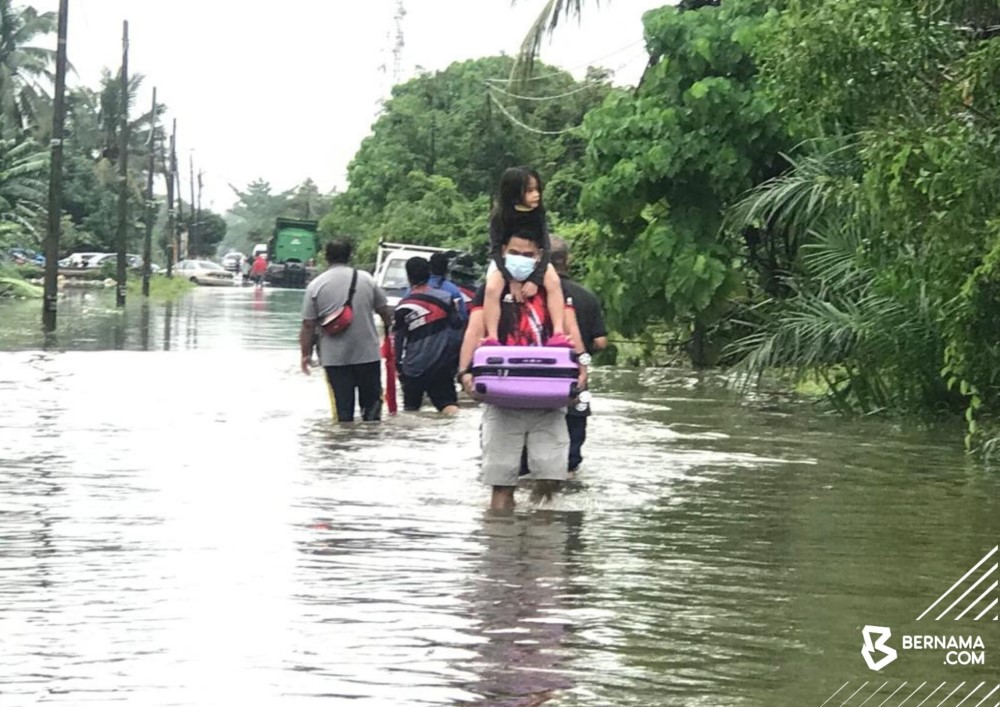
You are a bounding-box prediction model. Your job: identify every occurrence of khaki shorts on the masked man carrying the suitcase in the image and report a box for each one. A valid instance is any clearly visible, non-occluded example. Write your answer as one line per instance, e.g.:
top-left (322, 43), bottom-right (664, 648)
top-left (480, 405), bottom-right (569, 486)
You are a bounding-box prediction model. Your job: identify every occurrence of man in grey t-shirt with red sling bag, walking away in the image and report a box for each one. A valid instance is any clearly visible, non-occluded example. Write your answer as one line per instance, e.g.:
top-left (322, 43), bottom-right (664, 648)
top-left (299, 240), bottom-right (392, 422)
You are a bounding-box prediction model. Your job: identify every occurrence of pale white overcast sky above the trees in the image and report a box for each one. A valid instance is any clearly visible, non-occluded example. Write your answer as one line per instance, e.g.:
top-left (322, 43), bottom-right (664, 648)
top-left (24, 0), bottom-right (666, 211)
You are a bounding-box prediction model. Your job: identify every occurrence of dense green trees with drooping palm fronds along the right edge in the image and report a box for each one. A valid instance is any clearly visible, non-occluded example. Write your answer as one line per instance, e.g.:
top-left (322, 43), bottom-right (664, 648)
top-left (730, 0), bottom-right (1000, 443)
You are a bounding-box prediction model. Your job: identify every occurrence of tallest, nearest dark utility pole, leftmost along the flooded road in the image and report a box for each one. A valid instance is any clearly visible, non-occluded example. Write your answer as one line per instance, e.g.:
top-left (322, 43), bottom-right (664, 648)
top-left (42, 0), bottom-right (69, 332)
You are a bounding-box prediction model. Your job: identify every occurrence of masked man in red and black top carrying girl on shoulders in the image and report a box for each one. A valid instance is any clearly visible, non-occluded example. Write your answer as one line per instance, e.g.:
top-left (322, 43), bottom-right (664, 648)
top-left (458, 235), bottom-right (587, 511)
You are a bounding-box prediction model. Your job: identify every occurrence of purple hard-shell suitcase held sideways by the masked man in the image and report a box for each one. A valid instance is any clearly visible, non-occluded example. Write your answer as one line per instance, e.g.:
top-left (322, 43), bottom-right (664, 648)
top-left (472, 346), bottom-right (579, 410)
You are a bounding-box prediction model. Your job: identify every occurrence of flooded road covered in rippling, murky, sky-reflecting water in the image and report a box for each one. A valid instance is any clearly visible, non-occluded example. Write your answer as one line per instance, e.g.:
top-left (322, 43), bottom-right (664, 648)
top-left (0, 288), bottom-right (1000, 707)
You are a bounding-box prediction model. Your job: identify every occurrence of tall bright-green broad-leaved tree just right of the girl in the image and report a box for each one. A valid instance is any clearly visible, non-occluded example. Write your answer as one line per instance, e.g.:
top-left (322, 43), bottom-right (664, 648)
top-left (581, 0), bottom-right (789, 363)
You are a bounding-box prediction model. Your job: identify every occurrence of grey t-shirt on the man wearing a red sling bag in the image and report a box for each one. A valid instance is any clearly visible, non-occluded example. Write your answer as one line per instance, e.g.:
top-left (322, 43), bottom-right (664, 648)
top-left (302, 265), bottom-right (386, 366)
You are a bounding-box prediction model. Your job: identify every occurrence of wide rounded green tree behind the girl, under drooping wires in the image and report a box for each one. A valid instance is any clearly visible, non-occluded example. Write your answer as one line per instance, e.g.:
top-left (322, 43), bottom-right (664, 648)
top-left (321, 57), bottom-right (612, 260)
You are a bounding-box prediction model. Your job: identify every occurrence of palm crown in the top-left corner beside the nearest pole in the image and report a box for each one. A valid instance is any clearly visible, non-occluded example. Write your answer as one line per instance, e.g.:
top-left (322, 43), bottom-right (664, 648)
top-left (0, 0), bottom-right (58, 128)
